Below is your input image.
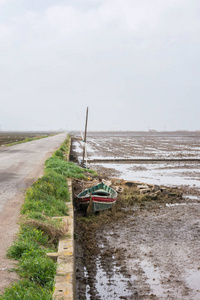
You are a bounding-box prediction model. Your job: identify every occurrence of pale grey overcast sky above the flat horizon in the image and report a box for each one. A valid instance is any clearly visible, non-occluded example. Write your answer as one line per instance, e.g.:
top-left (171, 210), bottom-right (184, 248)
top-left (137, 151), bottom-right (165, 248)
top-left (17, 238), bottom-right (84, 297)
top-left (0, 0), bottom-right (200, 130)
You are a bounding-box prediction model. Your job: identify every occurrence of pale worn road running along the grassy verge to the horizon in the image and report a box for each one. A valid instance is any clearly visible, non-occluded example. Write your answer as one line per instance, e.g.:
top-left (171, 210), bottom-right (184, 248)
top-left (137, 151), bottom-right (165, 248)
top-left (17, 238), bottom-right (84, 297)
top-left (0, 133), bottom-right (66, 293)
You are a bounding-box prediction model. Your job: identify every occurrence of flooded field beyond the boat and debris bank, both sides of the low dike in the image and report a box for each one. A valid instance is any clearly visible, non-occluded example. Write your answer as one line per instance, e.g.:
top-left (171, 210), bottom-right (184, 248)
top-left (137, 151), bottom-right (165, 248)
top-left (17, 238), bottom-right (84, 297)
top-left (73, 132), bottom-right (200, 188)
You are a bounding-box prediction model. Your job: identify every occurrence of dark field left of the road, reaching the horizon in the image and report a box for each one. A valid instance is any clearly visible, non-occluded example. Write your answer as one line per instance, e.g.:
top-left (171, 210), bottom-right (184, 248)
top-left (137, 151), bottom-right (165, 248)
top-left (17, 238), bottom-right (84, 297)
top-left (0, 131), bottom-right (56, 147)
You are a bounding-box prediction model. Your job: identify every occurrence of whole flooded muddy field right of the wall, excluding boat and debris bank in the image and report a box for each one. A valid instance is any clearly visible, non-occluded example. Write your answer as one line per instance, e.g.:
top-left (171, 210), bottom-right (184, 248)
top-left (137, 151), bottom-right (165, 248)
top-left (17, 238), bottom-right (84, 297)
top-left (73, 132), bottom-right (200, 300)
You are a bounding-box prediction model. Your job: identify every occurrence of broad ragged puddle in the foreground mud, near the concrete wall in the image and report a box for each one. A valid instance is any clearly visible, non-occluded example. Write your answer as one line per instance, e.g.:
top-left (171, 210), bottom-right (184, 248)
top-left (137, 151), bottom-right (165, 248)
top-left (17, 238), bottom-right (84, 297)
top-left (93, 258), bottom-right (134, 300)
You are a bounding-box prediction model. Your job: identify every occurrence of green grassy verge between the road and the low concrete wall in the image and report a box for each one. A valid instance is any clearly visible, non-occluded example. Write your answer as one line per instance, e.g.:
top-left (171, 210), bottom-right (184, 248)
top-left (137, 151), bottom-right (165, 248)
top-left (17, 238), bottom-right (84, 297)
top-left (0, 136), bottom-right (94, 300)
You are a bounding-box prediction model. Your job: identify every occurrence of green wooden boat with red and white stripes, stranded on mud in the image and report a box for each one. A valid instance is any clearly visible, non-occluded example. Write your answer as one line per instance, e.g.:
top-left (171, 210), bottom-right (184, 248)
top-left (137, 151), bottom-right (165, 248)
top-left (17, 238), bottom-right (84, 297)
top-left (77, 182), bottom-right (117, 212)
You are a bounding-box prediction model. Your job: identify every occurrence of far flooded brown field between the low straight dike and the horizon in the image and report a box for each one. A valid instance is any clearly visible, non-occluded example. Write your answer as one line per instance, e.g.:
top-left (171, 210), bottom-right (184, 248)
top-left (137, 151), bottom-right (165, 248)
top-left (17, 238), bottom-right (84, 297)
top-left (72, 132), bottom-right (200, 159)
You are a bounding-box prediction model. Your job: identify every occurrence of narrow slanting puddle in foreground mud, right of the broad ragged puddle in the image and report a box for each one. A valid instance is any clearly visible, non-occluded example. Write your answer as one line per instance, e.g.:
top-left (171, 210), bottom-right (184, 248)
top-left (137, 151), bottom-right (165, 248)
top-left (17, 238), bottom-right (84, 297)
top-left (140, 259), bottom-right (165, 297)
